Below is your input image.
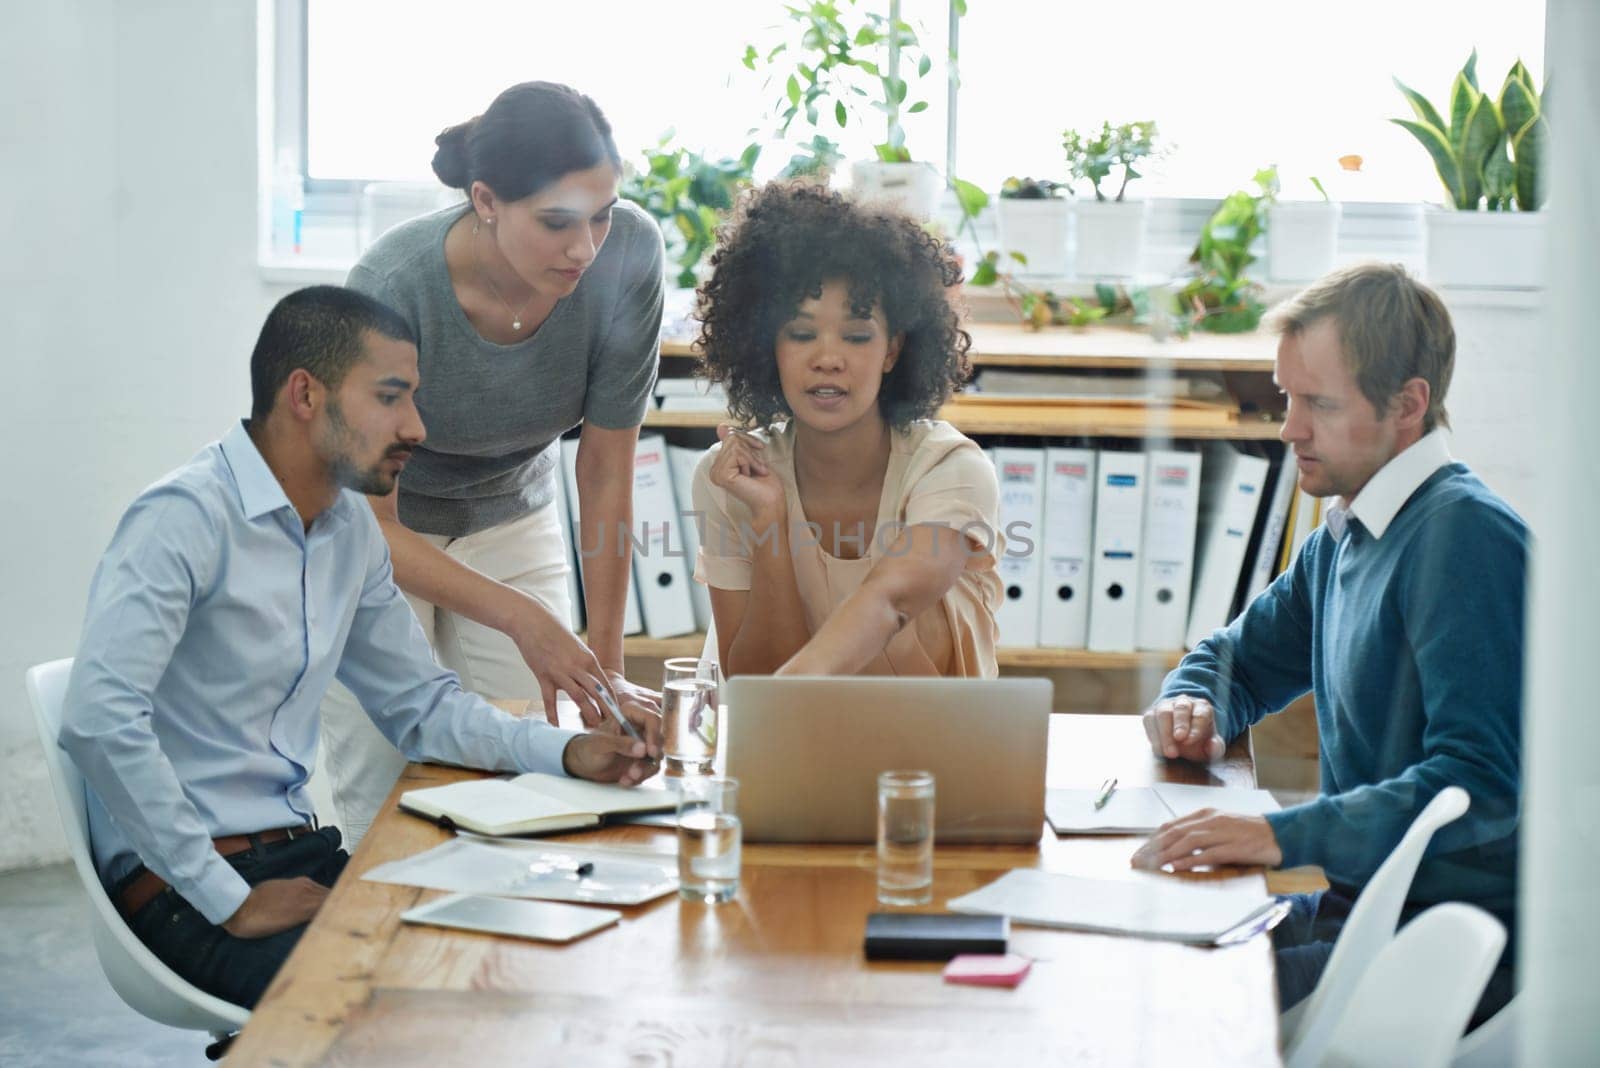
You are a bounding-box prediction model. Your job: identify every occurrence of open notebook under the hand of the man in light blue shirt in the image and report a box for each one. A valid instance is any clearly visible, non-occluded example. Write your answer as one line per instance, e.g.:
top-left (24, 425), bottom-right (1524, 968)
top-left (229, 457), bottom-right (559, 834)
top-left (400, 772), bottom-right (677, 836)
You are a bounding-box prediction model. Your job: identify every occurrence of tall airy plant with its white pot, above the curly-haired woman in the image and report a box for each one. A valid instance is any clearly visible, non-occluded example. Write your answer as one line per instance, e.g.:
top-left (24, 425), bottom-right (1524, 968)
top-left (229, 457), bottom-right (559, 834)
top-left (744, 0), bottom-right (944, 219)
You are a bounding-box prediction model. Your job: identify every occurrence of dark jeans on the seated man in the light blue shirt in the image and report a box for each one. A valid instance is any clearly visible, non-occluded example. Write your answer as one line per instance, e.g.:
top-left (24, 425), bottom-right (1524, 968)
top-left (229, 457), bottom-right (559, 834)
top-left (128, 827), bottom-right (350, 1009)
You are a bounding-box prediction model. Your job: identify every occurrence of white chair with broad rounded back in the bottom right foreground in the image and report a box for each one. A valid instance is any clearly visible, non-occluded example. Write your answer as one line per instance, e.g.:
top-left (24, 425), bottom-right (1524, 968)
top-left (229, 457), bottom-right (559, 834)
top-left (1288, 902), bottom-right (1506, 1068)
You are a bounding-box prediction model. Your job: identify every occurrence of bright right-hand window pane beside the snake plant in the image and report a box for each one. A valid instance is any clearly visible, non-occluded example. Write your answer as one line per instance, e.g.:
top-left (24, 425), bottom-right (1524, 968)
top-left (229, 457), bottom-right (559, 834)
top-left (957, 0), bottom-right (1544, 201)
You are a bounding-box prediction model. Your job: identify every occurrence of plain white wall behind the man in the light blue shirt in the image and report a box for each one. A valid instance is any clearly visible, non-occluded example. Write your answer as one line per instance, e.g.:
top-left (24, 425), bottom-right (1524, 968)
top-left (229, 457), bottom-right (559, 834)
top-left (0, 0), bottom-right (283, 870)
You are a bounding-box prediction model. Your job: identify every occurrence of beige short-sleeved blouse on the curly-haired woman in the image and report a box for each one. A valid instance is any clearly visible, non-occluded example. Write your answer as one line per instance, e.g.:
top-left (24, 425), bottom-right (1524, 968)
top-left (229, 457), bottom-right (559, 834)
top-left (694, 420), bottom-right (1003, 678)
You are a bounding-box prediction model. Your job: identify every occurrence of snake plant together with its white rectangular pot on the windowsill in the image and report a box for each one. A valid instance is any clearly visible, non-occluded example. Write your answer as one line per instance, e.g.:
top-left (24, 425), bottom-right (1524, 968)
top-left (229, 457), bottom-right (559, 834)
top-left (1390, 50), bottom-right (1550, 288)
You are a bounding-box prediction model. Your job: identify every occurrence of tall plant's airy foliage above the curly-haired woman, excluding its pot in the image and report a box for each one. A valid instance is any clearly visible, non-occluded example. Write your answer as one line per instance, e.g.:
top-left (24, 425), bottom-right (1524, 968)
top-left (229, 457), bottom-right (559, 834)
top-left (742, 0), bottom-right (965, 163)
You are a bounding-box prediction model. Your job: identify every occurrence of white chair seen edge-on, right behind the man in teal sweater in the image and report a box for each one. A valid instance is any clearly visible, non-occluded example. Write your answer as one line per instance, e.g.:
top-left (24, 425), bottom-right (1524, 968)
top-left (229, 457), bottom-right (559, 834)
top-left (1278, 787), bottom-right (1469, 1063)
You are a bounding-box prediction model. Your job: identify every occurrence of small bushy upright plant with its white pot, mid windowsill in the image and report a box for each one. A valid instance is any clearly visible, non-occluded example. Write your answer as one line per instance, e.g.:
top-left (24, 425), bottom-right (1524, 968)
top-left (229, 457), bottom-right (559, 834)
top-left (1061, 120), bottom-right (1157, 278)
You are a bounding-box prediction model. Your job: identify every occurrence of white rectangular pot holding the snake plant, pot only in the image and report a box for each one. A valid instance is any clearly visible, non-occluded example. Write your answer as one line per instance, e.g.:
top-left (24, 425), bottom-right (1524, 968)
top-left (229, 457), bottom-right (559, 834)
top-left (1422, 208), bottom-right (1546, 289)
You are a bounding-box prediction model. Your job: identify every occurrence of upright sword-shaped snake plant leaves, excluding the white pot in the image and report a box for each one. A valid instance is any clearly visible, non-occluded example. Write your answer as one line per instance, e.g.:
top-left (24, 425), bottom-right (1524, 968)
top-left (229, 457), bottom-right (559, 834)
top-left (1390, 48), bottom-right (1550, 211)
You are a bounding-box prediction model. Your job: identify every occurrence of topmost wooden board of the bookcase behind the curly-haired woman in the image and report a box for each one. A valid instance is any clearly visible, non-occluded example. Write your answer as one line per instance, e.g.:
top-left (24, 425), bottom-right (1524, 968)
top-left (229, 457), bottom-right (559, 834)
top-left (661, 323), bottom-right (1278, 373)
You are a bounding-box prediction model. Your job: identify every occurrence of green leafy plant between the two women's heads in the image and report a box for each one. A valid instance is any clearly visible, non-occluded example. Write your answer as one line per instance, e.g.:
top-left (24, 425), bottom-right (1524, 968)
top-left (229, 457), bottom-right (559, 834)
top-left (619, 130), bottom-right (762, 288)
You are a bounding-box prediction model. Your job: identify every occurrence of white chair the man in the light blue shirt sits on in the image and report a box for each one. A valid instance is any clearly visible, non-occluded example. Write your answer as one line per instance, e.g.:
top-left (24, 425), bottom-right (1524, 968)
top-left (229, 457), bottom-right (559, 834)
top-left (27, 660), bottom-right (250, 1060)
